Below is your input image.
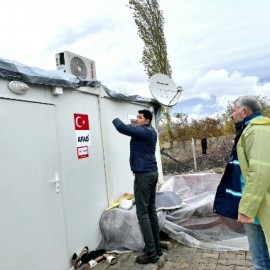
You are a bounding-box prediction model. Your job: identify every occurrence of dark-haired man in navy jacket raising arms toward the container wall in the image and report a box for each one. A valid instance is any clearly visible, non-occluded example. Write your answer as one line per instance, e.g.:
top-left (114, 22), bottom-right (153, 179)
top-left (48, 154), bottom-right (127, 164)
top-left (113, 110), bottom-right (162, 264)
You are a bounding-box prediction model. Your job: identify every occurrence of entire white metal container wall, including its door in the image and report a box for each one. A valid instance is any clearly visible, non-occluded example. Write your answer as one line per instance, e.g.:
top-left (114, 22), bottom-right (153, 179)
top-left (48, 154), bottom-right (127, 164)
top-left (0, 79), bottom-right (163, 270)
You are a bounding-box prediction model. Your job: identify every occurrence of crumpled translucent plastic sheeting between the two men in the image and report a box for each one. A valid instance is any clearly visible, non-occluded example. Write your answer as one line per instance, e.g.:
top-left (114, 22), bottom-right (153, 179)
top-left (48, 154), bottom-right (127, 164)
top-left (160, 173), bottom-right (248, 251)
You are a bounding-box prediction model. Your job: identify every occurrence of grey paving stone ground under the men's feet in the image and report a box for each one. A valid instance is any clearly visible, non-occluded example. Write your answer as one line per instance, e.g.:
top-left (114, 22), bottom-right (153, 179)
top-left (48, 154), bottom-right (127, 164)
top-left (79, 240), bottom-right (253, 270)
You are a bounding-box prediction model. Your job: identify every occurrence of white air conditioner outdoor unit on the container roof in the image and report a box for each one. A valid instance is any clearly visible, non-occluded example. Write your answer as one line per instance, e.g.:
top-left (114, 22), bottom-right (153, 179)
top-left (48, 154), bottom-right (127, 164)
top-left (55, 51), bottom-right (97, 81)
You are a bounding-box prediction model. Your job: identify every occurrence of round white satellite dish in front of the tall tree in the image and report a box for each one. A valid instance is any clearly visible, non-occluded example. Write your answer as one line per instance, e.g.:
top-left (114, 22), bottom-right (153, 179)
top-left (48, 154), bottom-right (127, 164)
top-left (148, 73), bottom-right (182, 106)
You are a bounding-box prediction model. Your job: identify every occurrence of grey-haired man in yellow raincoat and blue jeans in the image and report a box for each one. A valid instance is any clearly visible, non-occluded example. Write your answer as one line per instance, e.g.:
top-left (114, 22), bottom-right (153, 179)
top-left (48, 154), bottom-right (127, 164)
top-left (232, 96), bottom-right (270, 270)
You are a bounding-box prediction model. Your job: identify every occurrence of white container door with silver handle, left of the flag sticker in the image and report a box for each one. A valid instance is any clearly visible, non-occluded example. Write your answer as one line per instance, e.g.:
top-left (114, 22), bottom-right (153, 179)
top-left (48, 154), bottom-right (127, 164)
top-left (0, 99), bottom-right (68, 270)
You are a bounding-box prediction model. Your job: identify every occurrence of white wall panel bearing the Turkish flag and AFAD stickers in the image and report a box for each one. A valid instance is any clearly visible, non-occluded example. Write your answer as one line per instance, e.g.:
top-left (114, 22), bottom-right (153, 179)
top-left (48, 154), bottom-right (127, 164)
top-left (55, 91), bottom-right (108, 255)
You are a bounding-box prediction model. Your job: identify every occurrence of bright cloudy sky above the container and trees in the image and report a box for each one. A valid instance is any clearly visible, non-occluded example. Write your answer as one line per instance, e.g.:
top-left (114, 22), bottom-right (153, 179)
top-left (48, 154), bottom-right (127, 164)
top-left (0, 0), bottom-right (270, 119)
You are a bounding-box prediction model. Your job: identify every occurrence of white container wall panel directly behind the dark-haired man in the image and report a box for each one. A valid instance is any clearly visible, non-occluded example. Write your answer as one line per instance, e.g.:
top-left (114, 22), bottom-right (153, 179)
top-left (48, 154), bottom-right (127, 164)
top-left (101, 98), bottom-right (163, 204)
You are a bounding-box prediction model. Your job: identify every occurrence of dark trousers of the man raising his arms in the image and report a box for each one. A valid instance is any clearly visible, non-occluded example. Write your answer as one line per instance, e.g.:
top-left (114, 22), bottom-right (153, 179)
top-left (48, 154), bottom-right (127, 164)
top-left (134, 172), bottom-right (160, 254)
